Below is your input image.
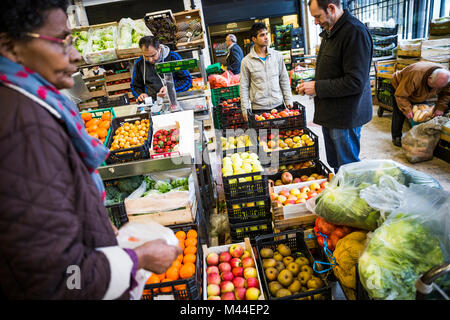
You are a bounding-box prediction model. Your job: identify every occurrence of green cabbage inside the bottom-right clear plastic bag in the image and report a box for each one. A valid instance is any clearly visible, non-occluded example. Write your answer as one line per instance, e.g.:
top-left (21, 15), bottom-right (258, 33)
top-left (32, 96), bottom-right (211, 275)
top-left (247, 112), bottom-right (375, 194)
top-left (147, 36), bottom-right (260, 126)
top-left (358, 214), bottom-right (444, 300)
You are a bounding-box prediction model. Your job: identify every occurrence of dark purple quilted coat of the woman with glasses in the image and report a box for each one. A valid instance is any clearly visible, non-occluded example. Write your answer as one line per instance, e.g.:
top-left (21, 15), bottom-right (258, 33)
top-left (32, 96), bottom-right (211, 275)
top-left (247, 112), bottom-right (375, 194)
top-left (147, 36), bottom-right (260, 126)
top-left (0, 85), bottom-right (129, 300)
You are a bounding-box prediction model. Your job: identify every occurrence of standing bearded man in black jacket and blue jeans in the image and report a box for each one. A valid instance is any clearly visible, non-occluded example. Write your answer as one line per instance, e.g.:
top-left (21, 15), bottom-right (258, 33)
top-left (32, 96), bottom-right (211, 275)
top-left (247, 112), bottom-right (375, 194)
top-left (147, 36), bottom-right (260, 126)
top-left (297, 0), bottom-right (373, 172)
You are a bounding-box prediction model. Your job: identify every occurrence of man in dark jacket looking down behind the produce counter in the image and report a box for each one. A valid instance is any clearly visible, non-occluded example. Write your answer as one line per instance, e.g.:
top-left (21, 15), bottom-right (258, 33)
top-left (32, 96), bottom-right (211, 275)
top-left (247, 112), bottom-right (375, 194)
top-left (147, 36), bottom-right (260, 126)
top-left (131, 36), bottom-right (192, 102)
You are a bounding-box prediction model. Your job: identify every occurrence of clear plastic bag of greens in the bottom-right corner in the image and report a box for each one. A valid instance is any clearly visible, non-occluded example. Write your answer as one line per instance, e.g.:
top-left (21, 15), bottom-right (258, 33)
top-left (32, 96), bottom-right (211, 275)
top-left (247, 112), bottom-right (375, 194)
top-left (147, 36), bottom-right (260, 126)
top-left (358, 184), bottom-right (450, 300)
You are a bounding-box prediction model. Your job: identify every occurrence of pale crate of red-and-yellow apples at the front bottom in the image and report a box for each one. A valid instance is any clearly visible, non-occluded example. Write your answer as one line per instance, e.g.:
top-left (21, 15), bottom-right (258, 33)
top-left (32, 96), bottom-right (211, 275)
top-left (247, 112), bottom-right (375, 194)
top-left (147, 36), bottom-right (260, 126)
top-left (203, 238), bottom-right (264, 300)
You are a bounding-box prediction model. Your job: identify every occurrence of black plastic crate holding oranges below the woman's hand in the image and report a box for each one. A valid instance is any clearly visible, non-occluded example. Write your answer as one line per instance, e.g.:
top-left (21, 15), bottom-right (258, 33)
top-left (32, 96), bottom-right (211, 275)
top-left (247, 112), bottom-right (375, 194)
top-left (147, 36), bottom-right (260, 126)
top-left (141, 223), bottom-right (203, 300)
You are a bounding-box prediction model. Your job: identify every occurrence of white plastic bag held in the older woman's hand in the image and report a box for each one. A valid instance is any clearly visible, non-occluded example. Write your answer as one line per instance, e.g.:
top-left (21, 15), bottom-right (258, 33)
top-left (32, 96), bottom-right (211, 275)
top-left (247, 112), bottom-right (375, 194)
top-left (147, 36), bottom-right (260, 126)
top-left (117, 222), bottom-right (178, 300)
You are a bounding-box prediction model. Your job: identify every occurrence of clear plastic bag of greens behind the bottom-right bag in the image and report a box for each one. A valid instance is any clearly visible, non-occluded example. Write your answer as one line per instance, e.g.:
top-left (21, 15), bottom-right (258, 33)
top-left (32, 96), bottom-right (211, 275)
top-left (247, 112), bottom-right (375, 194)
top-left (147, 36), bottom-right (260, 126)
top-left (312, 160), bottom-right (440, 231)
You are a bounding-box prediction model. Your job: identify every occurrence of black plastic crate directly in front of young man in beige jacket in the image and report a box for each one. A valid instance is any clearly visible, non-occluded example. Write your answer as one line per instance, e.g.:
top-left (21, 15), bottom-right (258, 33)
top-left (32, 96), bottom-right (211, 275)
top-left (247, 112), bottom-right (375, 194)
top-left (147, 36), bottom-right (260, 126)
top-left (247, 101), bottom-right (306, 129)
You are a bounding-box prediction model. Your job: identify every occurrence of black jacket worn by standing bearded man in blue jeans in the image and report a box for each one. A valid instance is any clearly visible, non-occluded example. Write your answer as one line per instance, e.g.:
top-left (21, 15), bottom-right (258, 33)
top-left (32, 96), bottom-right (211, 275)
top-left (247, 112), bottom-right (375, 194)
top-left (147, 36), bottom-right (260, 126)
top-left (314, 10), bottom-right (373, 129)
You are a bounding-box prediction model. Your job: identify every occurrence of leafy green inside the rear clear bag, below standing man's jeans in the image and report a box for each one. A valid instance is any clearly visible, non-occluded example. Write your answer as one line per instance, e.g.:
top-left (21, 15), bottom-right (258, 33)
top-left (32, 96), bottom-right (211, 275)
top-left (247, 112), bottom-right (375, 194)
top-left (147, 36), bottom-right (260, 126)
top-left (315, 184), bottom-right (382, 231)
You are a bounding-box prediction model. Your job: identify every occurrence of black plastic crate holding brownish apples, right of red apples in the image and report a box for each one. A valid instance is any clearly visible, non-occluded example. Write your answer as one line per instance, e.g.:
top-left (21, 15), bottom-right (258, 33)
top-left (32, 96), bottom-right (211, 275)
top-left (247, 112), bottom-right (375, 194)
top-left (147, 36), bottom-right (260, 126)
top-left (255, 229), bottom-right (332, 300)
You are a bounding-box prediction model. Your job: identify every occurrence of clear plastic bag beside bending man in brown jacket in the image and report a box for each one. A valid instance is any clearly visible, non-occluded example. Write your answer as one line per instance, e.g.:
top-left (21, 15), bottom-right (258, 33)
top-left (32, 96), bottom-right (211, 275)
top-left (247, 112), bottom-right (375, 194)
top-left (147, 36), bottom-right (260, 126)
top-left (402, 117), bottom-right (448, 163)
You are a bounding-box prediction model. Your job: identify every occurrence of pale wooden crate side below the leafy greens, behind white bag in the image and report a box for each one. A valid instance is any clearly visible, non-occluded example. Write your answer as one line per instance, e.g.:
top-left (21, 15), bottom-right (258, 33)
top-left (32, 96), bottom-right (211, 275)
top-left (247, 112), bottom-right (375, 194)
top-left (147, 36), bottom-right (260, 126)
top-left (128, 203), bottom-right (197, 226)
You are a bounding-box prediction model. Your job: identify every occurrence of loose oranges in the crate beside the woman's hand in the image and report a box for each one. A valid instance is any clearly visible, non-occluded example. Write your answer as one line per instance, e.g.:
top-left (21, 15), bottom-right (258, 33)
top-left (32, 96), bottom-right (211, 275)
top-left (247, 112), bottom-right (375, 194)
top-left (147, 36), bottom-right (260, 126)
top-left (143, 229), bottom-right (198, 295)
